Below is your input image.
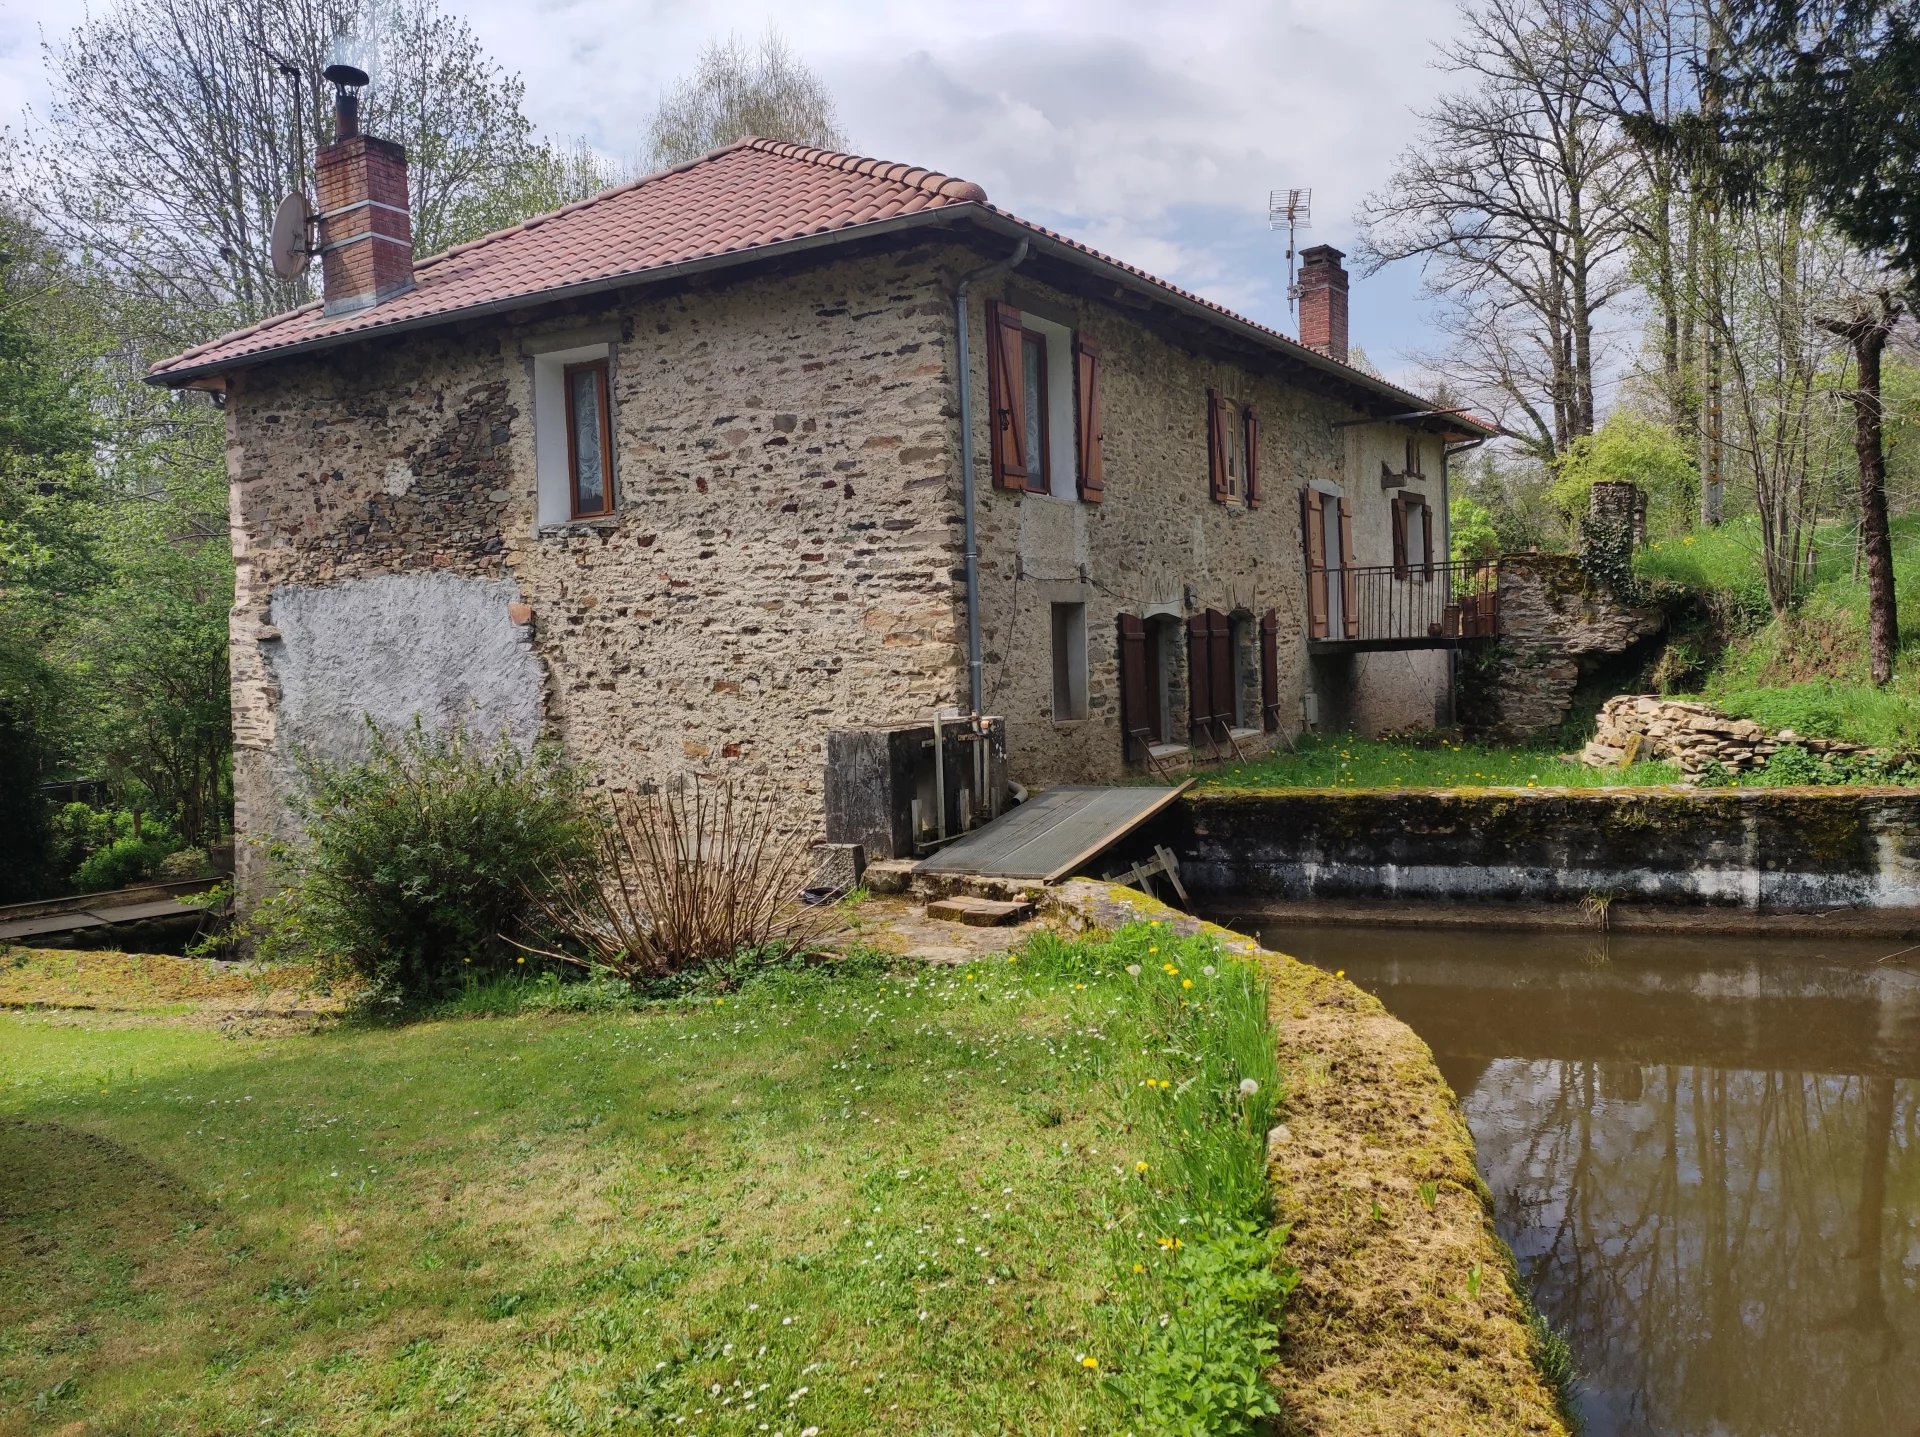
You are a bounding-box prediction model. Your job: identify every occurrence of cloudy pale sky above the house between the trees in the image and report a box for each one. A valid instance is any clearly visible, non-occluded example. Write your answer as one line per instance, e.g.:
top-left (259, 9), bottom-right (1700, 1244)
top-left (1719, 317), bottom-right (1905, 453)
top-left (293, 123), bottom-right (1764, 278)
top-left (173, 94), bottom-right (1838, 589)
top-left (0, 0), bottom-right (1453, 378)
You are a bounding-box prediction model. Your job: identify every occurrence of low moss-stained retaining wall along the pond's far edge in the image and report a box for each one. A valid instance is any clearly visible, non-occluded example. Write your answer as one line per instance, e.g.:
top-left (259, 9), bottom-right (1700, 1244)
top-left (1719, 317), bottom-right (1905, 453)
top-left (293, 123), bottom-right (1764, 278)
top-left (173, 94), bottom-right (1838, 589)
top-left (1167, 788), bottom-right (1920, 913)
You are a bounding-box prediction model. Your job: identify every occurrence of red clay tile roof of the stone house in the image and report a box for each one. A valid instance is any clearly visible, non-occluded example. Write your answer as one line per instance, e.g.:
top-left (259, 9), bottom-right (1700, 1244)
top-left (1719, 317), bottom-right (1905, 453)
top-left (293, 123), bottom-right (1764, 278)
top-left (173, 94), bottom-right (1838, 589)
top-left (148, 138), bottom-right (1480, 428)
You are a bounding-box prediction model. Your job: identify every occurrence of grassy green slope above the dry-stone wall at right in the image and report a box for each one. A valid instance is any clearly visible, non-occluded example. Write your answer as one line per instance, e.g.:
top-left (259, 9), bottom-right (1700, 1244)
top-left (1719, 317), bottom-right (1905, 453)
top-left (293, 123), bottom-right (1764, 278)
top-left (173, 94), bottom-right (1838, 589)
top-left (1634, 517), bottom-right (1920, 749)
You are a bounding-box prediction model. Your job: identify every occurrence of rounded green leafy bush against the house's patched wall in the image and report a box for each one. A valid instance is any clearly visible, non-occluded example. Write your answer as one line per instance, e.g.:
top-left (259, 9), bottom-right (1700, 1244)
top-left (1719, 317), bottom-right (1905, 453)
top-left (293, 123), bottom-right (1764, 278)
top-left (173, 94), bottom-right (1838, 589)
top-left (255, 722), bottom-right (593, 1001)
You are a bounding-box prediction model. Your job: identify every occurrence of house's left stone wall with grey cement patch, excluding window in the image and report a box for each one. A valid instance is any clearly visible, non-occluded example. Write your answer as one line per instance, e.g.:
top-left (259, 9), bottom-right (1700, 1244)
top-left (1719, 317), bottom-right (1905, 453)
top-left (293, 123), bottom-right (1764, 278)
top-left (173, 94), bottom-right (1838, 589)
top-left (228, 250), bottom-right (964, 899)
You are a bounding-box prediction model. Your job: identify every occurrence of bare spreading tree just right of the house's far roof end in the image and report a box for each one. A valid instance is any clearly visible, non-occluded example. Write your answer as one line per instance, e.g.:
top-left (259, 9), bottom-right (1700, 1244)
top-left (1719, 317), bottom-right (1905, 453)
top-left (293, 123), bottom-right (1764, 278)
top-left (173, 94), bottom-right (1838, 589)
top-left (1359, 0), bottom-right (1630, 459)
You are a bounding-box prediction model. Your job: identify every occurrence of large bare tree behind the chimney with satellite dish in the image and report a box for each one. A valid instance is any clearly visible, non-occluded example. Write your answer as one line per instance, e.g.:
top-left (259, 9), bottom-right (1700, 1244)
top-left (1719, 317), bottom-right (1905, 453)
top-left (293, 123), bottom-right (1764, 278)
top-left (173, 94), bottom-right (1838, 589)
top-left (0, 0), bottom-right (599, 340)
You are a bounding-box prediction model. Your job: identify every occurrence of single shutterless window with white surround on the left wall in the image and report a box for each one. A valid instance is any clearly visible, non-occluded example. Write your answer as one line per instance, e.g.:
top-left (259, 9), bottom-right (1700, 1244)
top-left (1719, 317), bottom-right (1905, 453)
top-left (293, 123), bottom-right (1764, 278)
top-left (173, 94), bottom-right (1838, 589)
top-left (530, 342), bottom-right (620, 526)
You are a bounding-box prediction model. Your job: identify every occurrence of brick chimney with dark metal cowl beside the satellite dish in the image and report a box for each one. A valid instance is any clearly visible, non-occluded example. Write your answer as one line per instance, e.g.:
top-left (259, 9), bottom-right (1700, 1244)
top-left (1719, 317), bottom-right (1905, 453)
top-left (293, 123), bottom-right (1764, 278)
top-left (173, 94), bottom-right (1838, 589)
top-left (313, 82), bottom-right (413, 315)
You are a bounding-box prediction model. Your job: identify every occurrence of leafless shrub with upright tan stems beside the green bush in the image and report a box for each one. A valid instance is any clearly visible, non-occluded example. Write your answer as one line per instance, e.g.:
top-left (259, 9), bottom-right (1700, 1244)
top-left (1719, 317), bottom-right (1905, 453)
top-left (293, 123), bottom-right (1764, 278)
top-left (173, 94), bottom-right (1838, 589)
top-left (528, 782), bottom-right (841, 982)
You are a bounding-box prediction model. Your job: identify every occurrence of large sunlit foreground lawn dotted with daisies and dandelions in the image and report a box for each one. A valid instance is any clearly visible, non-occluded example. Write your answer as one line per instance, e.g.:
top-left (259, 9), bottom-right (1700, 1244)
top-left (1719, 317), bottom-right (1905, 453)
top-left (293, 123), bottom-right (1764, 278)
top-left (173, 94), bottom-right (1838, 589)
top-left (0, 928), bottom-right (1277, 1437)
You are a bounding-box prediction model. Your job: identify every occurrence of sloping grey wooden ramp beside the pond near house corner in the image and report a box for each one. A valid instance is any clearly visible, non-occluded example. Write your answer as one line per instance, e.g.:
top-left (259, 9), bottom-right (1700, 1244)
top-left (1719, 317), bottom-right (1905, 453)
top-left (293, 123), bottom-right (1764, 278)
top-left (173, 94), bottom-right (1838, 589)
top-left (914, 780), bottom-right (1192, 884)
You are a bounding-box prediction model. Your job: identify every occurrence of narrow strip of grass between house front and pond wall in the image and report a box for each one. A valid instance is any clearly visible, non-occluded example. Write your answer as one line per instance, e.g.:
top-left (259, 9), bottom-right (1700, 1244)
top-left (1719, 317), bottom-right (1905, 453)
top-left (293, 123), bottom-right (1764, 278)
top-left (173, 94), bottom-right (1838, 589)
top-left (1200, 734), bottom-right (1680, 788)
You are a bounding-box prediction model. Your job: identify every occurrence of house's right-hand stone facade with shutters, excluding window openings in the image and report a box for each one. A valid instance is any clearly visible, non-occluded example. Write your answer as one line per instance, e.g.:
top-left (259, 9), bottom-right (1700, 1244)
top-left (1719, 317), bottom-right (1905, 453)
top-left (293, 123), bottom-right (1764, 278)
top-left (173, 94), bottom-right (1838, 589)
top-left (956, 271), bottom-right (1448, 782)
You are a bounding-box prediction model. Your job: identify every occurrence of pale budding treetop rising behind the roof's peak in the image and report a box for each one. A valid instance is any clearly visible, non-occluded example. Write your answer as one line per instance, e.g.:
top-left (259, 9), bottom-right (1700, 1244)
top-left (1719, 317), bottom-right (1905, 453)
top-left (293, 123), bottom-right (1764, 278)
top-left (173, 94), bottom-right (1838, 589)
top-left (647, 25), bottom-right (847, 167)
